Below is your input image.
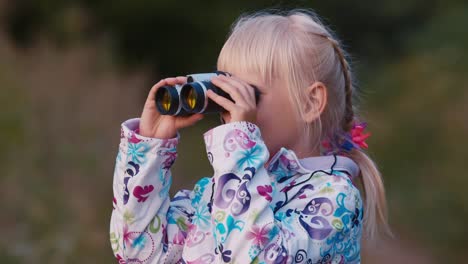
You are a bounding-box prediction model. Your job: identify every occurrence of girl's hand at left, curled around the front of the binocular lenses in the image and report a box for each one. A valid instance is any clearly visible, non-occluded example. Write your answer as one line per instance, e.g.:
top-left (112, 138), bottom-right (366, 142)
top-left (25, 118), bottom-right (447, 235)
top-left (139, 76), bottom-right (203, 139)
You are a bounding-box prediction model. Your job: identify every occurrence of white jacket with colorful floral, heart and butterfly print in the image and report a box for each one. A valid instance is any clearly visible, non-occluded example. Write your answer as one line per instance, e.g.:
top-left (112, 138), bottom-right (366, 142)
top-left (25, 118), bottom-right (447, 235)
top-left (110, 118), bottom-right (363, 264)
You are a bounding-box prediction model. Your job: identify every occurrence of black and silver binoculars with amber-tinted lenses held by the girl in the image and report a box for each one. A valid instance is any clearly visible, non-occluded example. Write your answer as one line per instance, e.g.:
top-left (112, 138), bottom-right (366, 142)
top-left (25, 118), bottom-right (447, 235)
top-left (155, 71), bottom-right (260, 116)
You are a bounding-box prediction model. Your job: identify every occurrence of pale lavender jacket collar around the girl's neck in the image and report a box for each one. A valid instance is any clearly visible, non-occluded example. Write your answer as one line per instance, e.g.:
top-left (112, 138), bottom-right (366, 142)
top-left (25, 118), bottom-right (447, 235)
top-left (267, 147), bottom-right (359, 183)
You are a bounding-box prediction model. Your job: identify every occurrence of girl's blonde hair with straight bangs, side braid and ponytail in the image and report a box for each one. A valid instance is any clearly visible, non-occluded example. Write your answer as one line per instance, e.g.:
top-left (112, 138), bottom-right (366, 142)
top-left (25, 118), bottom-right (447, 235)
top-left (217, 8), bottom-right (391, 239)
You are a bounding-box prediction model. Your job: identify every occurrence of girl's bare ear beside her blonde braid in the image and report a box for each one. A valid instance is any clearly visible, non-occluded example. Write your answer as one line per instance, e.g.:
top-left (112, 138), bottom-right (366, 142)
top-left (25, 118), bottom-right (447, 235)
top-left (304, 82), bottom-right (327, 123)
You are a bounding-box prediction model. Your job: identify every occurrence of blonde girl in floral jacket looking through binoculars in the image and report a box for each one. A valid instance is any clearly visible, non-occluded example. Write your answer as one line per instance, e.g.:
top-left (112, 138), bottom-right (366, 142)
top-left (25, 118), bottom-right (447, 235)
top-left (110, 9), bottom-right (387, 263)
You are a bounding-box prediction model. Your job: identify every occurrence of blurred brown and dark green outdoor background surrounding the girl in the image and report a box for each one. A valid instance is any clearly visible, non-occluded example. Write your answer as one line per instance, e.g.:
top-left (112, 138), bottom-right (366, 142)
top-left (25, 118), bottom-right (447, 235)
top-left (0, 0), bottom-right (468, 263)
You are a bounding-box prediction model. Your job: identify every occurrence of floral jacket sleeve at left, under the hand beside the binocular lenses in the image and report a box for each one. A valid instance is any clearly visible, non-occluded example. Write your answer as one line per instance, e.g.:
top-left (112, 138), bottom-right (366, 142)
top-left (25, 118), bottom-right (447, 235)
top-left (110, 118), bottom-right (193, 263)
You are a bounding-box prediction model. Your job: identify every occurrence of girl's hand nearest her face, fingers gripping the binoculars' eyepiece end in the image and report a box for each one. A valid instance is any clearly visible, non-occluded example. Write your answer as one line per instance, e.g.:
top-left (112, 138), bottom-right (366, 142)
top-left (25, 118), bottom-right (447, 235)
top-left (207, 75), bottom-right (257, 123)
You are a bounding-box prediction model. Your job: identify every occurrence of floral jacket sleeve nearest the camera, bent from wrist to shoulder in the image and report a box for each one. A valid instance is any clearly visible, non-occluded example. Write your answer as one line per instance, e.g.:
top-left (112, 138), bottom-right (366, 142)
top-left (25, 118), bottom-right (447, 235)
top-left (204, 121), bottom-right (362, 263)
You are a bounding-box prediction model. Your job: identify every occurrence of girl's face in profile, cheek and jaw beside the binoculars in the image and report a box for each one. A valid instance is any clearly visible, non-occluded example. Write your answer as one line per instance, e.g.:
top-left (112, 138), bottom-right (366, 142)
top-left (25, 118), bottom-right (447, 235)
top-left (222, 72), bottom-right (301, 163)
